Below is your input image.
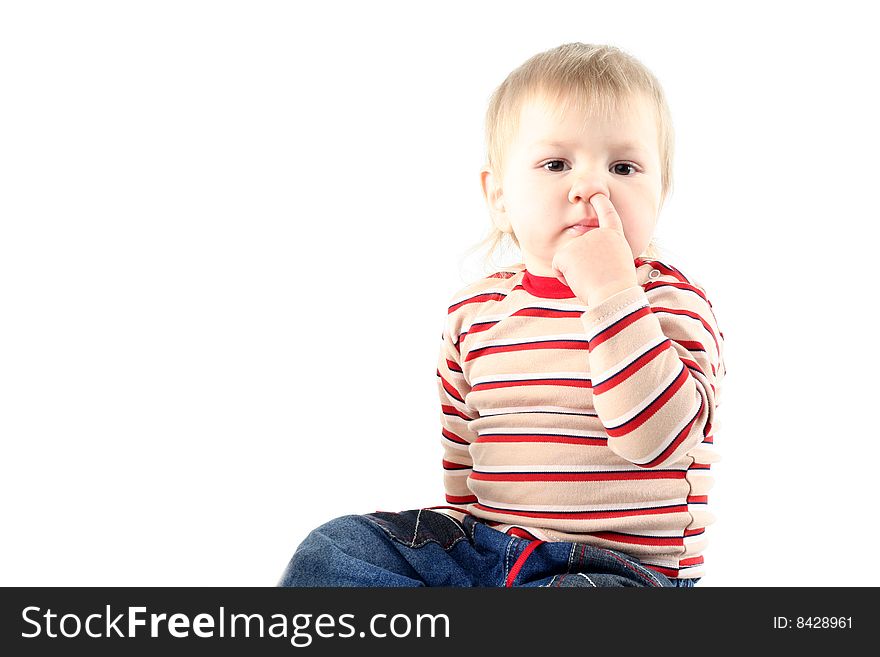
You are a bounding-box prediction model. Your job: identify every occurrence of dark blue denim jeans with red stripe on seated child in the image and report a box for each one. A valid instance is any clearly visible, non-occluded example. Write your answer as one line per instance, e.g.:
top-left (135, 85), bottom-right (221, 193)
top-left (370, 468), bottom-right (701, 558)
top-left (278, 509), bottom-right (699, 587)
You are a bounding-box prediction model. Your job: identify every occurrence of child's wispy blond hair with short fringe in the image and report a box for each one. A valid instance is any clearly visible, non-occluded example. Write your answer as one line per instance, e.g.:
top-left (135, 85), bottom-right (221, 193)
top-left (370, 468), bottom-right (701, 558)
top-left (469, 42), bottom-right (674, 264)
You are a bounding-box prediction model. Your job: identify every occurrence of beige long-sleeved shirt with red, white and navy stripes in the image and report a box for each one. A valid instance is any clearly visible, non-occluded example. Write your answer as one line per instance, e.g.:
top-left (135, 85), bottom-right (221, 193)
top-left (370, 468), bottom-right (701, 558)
top-left (433, 258), bottom-right (725, 578)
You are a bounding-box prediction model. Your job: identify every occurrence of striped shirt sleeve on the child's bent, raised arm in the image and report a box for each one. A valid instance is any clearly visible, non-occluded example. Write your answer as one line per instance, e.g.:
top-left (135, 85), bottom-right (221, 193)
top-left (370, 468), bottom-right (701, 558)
top-left (581, 274), bottom-right (725, 468)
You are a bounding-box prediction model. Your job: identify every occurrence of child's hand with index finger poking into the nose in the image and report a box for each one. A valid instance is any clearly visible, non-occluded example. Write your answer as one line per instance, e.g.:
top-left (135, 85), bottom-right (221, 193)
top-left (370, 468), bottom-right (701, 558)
top-left (551, 194), bottom-right (639, 306)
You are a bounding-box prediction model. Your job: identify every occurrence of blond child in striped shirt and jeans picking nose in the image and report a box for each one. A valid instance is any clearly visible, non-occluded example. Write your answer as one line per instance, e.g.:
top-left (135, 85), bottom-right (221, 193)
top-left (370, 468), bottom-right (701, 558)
top-left (280, 43), bottom-right (725, 587)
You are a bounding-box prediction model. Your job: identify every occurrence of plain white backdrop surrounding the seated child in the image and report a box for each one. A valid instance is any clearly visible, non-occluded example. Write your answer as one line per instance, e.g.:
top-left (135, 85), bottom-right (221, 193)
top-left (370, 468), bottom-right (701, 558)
top-left (0, 0), bottom-right (880, 586)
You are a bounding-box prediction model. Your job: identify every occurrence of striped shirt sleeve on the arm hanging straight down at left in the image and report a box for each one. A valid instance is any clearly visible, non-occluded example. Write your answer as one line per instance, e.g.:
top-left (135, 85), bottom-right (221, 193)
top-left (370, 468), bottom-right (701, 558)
top-left (437, 322), bottom-right (478, 505)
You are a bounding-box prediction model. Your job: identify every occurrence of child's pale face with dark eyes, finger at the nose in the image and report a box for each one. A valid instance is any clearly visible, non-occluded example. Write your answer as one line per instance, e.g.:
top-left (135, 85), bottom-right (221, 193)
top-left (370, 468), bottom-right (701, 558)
top-left (482, 91), bottom-right (661, 276)
